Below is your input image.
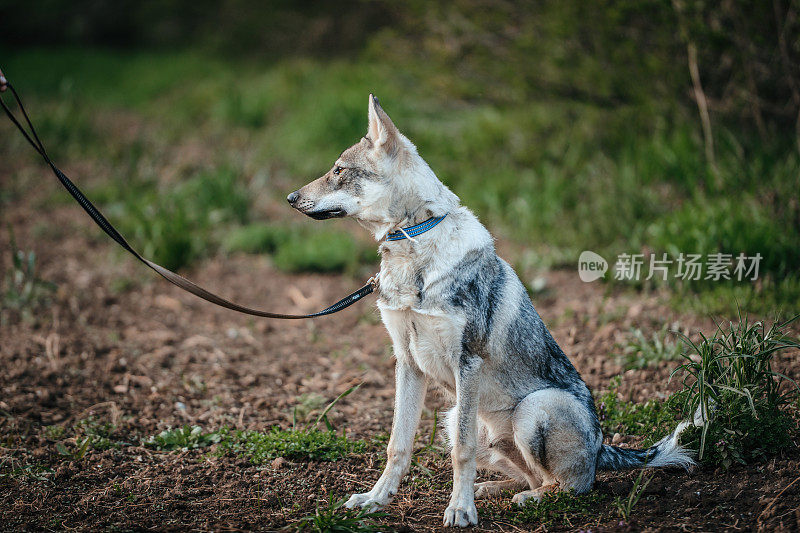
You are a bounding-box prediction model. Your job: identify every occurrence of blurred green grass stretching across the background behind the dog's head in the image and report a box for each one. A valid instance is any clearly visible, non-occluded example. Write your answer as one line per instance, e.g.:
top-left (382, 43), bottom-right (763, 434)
top-left (0, 49), bottom-right (800, 313)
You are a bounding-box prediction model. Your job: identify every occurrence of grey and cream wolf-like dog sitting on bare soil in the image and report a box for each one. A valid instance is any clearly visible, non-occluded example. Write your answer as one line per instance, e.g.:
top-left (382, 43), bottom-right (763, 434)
top-left (287, 95), bottom-right (693, 527)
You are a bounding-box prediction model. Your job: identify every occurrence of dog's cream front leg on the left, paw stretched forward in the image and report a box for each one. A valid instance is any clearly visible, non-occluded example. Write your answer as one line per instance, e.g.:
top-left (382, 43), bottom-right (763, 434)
top-left (345, 359), bottom-right (425, 510)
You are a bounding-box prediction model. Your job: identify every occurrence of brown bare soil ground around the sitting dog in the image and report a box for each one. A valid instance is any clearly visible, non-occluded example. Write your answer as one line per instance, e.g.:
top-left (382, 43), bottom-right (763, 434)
top-left (0, 178), bottom-right (800, 531)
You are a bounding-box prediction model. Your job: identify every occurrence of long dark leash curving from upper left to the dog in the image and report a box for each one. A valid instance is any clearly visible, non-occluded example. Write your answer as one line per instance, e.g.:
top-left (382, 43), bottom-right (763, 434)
top-left (0, 70), bottom-right (377, 319)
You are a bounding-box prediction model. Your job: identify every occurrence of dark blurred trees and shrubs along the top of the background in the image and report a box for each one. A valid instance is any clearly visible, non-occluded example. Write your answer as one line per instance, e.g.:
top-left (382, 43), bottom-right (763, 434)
top-left (0, 0), bottom-right (800, 141)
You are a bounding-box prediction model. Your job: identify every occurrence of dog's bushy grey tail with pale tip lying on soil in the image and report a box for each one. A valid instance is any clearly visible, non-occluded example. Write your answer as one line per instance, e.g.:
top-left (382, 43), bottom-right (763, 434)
top-left (597, 422), bottom-right (694, 470)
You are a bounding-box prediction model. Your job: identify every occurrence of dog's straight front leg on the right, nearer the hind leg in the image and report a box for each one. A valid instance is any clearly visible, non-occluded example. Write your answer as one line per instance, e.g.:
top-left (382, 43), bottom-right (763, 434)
top-left (444, 357), bottom-right (483, 527)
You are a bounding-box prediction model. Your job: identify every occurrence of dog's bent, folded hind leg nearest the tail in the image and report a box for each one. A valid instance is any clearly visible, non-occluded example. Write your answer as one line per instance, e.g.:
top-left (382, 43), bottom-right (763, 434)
top-left (513, 389), bottom-right (602, 505)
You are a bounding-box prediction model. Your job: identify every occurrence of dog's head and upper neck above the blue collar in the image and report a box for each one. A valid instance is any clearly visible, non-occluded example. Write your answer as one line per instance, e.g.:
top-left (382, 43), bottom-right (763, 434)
top-left (287, 95), bottom-right (458, 238)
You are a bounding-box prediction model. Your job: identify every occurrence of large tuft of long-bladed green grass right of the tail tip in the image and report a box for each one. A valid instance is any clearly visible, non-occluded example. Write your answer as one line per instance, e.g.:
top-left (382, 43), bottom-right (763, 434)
top-left (673, 314), bottom-right (800, 468)
